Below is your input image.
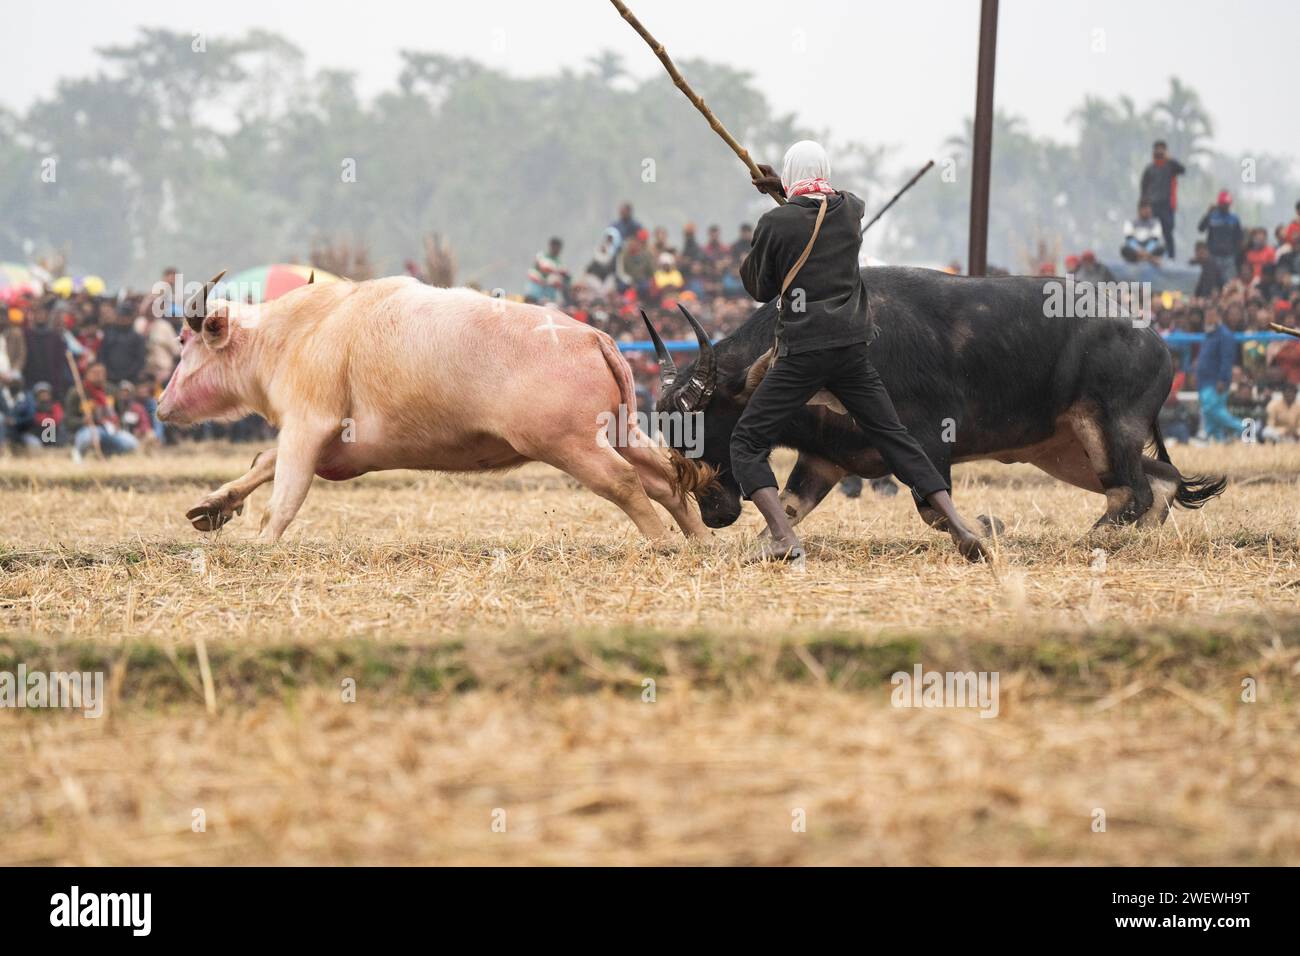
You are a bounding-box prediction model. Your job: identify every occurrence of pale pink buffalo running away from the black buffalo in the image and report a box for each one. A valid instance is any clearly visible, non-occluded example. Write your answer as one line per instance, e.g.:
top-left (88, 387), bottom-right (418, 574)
top-left (159, 276), bottom-right (711, 542)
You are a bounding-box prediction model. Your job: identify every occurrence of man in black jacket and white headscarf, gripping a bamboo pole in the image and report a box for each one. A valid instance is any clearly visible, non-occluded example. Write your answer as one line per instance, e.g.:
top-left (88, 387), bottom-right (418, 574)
top-left (731, 140), bottom-right (985, 561)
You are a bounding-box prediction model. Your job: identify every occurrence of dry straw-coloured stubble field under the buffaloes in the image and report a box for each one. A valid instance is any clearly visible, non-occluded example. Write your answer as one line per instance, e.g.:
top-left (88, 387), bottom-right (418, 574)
top-left (0, 447), bottom-right (1300, 864)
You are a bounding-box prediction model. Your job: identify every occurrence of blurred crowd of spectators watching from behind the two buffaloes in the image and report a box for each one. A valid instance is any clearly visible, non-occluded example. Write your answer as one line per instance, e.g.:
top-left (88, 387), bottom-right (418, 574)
top-left (10, 170), bottom-right (1300, 457)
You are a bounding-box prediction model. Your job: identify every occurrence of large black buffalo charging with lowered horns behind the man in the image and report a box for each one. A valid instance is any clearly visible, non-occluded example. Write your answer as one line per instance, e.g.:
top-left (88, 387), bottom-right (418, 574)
top-left (646, 267), bottom-right (1227, 538)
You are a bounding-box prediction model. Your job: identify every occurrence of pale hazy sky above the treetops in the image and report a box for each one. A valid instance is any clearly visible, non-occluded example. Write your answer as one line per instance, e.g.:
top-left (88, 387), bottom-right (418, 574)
top-left (10, 0), bottom-right (1300, 165)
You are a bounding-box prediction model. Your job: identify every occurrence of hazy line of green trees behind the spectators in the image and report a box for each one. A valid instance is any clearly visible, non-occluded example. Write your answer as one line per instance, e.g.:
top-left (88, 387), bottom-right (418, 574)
top-left (0, 29), bottom-right (1300, 290)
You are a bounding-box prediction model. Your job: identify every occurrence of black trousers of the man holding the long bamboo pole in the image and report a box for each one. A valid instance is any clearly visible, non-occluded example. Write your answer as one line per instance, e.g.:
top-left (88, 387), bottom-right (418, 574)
top-left (731, 342), bottom-right (949, 501)
